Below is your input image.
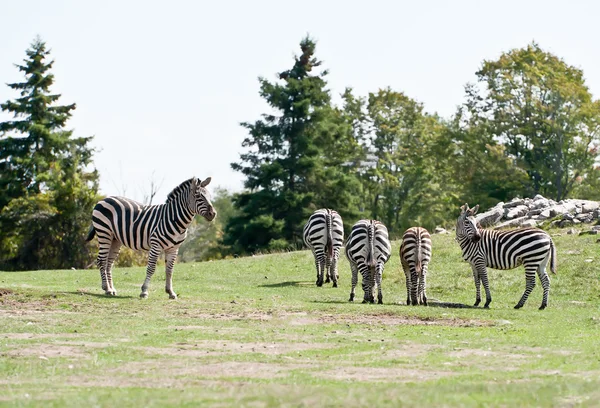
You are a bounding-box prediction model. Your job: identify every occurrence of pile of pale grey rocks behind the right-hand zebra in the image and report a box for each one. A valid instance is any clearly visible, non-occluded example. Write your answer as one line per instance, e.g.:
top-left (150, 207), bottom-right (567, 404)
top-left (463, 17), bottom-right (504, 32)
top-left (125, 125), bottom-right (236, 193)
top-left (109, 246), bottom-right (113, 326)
top-left (475, 194), bottom-right (600, 229)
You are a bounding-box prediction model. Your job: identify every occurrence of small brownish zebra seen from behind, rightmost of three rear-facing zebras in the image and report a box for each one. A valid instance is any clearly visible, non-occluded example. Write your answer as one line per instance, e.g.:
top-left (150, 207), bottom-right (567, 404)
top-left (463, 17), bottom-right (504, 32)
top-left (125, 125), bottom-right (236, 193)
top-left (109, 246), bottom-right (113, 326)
top-left (400, 227), bottom-right (431, 306)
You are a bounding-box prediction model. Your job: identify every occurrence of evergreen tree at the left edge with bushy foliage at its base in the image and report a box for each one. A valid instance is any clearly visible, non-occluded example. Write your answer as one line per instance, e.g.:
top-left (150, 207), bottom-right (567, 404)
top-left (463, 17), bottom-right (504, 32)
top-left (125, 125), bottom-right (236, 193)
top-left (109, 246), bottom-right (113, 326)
top-left (0, 39), bottom-right (98, 269)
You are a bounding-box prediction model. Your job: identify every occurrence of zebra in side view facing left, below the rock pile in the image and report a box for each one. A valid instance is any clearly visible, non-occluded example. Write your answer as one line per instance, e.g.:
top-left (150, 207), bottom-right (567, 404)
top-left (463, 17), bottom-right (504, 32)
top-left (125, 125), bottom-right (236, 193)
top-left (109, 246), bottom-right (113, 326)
top-left (456, 204), bottom-right (556, 310)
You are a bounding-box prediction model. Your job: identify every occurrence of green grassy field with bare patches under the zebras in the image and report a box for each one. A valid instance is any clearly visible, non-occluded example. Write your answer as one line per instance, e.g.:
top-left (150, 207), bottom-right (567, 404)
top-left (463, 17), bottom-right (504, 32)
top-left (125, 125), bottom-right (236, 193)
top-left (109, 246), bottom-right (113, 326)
top-left (0, 234), bottom-right (600, 407)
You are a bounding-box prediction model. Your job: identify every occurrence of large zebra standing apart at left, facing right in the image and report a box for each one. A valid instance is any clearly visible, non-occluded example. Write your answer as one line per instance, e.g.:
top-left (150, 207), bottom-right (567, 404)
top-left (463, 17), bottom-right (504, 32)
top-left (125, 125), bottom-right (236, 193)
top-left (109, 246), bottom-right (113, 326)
top-left (86, 177), bottom-right (217, 299)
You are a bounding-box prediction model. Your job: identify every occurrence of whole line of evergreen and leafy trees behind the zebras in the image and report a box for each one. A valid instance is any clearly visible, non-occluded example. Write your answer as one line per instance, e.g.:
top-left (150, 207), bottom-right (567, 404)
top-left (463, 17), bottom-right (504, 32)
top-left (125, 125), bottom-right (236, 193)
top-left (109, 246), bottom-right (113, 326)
top-left (0, 37), bottom-right (600, 269)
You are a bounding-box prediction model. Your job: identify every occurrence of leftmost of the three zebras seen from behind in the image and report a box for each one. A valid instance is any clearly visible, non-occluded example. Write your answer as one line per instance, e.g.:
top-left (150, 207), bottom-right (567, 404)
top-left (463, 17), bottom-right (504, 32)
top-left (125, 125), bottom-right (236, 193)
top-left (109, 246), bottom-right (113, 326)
top-left (303, 209), bottom-right (344, 288)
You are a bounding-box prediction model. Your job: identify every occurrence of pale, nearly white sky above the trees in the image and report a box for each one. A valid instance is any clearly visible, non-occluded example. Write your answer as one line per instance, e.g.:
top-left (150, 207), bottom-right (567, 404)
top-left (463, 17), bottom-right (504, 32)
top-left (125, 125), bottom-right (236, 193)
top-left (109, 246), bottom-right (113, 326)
top-left (0, 0), bottom-right (600, 203)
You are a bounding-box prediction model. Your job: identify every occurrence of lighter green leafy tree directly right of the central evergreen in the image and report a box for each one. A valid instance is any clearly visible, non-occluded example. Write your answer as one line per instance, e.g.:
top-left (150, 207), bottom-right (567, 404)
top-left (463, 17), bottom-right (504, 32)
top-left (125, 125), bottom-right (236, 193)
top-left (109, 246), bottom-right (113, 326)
top-left (363, 88), bottom-right (457, 236)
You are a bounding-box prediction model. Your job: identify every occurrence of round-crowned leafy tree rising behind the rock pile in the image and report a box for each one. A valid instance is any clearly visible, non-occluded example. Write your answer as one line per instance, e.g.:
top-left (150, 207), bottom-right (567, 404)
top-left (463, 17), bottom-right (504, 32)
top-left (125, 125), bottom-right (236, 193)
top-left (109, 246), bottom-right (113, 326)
top-left (465, 43), bottom-right (600, 200)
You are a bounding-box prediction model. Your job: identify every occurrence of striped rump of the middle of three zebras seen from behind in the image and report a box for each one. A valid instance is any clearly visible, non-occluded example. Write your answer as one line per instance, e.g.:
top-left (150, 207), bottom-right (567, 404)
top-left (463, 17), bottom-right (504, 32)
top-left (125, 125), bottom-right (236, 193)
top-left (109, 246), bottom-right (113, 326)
top-left (346, 220), bottom-right (392, 267)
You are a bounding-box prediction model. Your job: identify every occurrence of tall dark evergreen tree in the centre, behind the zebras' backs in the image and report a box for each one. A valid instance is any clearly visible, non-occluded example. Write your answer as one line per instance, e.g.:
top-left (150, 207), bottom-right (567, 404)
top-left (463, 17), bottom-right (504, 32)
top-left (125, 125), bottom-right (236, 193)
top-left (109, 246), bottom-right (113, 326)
top-left (224, 37), bottom-right (360, 252)
